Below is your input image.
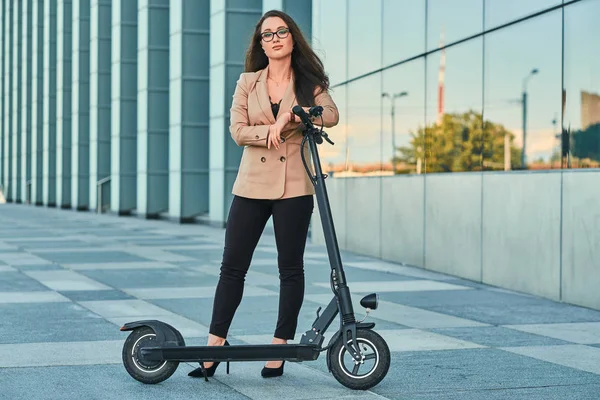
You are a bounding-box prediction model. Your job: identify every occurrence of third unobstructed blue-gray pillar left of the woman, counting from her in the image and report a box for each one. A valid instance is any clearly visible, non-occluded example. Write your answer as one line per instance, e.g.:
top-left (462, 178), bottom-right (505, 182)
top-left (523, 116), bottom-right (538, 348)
top-left (110, 0), bottom-right (138, 214)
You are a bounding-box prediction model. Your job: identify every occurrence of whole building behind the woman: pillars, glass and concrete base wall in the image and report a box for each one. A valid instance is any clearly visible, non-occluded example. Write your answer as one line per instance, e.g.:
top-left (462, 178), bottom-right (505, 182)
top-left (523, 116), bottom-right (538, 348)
top-left (0, 0), bottom-right (600, 309)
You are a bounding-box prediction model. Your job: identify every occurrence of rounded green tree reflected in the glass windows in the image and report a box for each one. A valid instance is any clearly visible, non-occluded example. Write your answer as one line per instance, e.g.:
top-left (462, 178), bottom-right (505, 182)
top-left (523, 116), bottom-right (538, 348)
top-left (397, 111), bottom-right (521, 172)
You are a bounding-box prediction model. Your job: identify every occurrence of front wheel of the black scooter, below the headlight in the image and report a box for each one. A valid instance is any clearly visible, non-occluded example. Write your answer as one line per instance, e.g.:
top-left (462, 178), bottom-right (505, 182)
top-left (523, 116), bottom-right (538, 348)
top-left (328, 329), bottom-right (391, 390)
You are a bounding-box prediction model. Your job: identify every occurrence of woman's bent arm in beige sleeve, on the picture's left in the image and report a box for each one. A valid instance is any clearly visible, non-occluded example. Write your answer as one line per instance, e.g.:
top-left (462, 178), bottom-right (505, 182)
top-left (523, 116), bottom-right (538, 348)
top-left (229, 73), bottom-right (269, 147)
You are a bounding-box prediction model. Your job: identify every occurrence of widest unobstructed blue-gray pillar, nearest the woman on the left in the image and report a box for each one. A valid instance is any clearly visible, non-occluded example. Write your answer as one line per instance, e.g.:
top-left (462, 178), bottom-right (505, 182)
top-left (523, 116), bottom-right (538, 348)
top-left (169, 0), bottom-right (210, 221)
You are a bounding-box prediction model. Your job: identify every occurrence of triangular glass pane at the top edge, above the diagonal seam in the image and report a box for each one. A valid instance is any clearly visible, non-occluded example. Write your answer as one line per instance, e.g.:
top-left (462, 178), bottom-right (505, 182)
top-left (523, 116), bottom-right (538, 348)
top-left (484, 0), bottom-right (561, 30)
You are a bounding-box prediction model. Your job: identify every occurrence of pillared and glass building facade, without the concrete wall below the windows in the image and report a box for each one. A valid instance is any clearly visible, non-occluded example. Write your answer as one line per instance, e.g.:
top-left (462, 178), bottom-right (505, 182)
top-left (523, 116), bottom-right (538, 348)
top-left (0, 0), bottom-right (600, 216)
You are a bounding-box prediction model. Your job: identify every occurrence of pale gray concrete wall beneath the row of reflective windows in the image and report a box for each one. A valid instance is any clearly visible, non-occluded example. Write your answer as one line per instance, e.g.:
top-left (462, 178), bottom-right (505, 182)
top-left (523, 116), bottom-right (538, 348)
top-left (311, 170), bottom-right (600, 309)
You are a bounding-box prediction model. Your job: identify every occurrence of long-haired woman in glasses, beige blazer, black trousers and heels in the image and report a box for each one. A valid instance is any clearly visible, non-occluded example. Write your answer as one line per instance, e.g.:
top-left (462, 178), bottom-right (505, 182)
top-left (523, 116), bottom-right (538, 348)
top-left (189, 11), bottom-right (339, 377)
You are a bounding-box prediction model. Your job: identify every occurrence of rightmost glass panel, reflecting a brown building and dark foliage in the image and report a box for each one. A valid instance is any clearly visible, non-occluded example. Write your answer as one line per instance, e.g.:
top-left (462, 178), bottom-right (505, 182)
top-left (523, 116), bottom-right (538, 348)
top-left (555, 1), bottom-right (600, 168)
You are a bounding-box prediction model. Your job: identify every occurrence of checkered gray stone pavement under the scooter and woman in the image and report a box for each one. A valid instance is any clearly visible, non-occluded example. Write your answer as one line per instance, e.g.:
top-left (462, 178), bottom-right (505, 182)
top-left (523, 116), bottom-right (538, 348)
top-left (0, 204), bottom-right (600, 400)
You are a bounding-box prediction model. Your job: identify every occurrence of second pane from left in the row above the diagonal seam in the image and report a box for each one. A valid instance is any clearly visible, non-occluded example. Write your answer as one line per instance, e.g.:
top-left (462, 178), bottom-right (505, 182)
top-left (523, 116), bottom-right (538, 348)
top-left (346, 0), bottom-right (382, 79)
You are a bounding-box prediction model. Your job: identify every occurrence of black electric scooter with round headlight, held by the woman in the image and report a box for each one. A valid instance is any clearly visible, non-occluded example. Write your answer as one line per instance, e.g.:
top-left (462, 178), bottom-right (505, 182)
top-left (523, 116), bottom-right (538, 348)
top-left (120, 106), bottom-right (391, 390)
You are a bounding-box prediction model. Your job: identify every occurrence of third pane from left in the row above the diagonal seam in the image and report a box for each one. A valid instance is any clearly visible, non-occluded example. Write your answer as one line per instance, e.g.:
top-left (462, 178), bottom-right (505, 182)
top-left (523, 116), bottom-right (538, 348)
top-left (382, 0), bottom-right (425, 67)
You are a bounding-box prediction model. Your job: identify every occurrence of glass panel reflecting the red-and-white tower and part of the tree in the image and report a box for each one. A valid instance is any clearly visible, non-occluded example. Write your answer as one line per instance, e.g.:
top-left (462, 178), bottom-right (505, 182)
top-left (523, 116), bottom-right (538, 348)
top-left (421, 38), bottom-right (483, 173)
